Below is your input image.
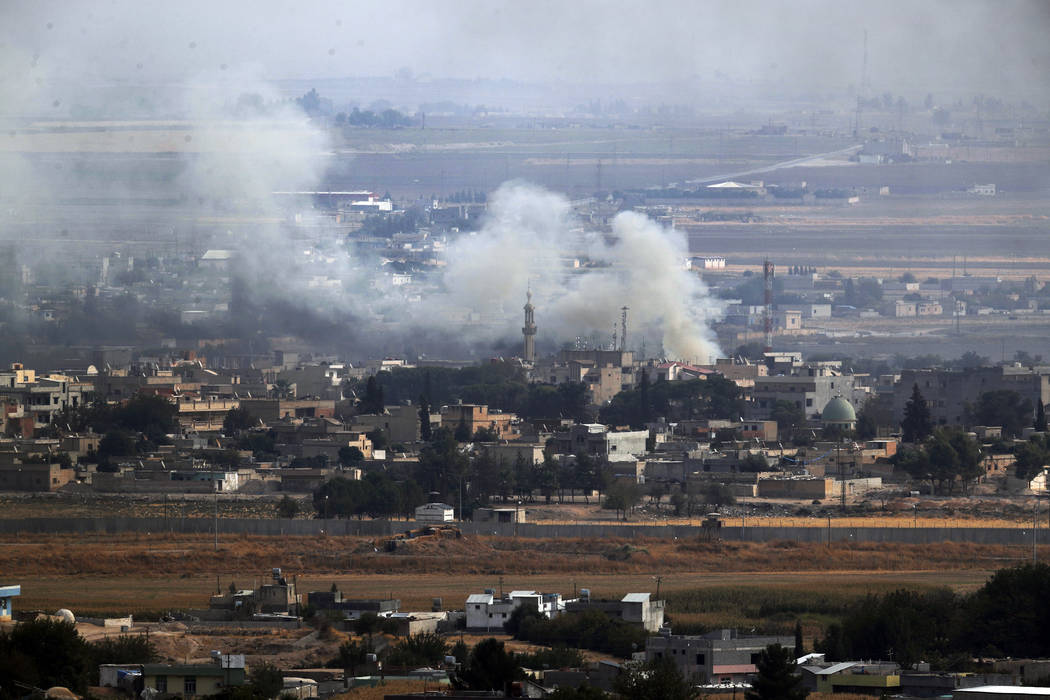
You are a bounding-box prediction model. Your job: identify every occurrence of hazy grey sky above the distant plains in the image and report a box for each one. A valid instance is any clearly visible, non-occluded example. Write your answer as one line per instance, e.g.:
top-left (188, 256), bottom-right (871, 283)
top-left (0, 0), bottom-right (1050, 96)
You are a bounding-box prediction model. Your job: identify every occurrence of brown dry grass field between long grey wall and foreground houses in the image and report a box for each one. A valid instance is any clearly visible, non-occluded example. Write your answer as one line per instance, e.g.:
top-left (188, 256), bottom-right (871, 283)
top-left (0, 535), bottom-right (1016, 614)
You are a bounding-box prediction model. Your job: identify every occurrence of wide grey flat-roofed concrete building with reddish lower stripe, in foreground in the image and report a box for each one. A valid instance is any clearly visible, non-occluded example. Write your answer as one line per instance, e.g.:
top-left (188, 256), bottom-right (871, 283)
top-left (646, 630), bottom-right (795, 684)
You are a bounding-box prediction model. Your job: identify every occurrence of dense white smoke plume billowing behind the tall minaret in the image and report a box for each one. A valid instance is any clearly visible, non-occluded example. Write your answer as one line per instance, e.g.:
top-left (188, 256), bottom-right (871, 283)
top-left (416, 183), bottom-right (719, 362)
